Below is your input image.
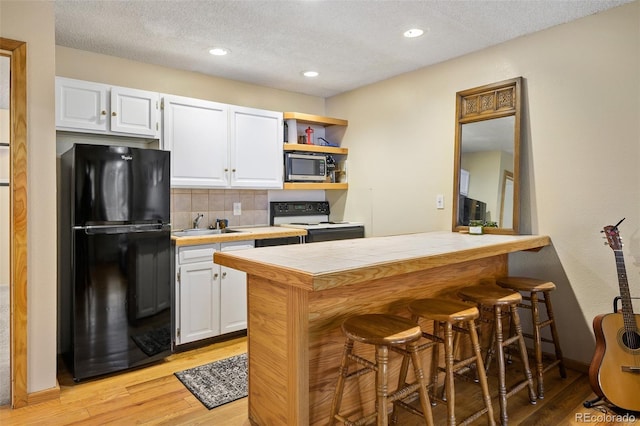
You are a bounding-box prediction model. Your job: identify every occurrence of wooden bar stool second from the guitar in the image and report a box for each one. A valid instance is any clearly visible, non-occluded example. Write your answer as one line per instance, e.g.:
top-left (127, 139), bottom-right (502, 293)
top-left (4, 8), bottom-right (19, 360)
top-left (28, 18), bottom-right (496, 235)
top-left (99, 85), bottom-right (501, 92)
top-left (458, 285), bottom-right (536, 426)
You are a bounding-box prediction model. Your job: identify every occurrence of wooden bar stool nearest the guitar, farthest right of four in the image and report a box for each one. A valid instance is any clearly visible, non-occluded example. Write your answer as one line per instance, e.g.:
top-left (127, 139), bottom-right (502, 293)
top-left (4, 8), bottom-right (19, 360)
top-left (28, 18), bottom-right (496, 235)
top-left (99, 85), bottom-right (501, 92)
top-left (496, 277), bottom-right (567, 399)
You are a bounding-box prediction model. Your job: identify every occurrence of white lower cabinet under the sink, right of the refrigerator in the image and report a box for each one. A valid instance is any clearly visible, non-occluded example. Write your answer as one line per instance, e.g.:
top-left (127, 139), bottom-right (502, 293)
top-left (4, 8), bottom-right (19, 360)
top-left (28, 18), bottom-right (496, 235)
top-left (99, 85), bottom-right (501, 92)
top-left (175, 241), bottom-right (254, 345)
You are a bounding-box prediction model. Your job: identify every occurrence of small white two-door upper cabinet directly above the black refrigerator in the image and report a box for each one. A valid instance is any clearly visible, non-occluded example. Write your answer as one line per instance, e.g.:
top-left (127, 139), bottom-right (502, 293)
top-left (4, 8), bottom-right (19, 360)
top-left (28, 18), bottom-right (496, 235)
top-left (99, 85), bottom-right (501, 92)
top-left (56, 77), bottom-right (160, 139)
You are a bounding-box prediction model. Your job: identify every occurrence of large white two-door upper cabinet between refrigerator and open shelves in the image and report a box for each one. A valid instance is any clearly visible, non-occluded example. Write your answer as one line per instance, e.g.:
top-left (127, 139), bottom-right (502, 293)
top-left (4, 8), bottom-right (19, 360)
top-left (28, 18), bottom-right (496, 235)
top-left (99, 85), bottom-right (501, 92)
top-left (162, 95), bottom-right (283, 189)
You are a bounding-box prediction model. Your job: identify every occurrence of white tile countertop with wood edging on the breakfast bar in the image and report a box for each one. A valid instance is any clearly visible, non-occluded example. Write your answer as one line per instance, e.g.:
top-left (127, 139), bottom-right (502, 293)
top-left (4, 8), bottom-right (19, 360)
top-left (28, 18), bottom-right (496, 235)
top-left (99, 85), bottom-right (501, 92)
top-left (214, 231), bottom-right (551, 291)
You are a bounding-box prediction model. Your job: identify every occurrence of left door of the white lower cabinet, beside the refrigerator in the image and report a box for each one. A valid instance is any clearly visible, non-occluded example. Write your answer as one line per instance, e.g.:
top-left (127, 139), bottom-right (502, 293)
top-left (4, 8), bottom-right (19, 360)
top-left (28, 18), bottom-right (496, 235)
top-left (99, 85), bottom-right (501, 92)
top-left (178, 262), bottom-right (220, 344)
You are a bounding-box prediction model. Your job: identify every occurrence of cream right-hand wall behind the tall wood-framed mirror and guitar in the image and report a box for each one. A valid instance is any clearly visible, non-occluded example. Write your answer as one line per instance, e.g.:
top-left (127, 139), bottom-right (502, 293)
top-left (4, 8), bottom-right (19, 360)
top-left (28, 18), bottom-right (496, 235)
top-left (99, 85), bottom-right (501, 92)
top-left (327, 1), bottom-right (640, 363)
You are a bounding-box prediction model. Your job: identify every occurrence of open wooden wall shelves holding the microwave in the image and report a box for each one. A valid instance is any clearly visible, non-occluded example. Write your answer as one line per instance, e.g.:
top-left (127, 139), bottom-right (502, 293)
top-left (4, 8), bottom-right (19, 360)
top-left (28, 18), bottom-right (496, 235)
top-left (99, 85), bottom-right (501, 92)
top-left (283, 112), bottom-right (349, 189)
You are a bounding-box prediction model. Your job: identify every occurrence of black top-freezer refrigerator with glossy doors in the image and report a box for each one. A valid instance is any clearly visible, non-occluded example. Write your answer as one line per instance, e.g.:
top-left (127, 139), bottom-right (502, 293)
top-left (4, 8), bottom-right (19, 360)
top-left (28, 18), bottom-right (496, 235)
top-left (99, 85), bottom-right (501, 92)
top-left (58, 144), bottom-right (172, 381)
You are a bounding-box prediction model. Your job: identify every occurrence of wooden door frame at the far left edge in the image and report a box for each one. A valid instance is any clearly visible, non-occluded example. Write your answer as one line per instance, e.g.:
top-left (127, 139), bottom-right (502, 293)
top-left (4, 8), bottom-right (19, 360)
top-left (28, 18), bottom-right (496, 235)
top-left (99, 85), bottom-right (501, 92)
top-left (0, 37), bottom-right (28, 408)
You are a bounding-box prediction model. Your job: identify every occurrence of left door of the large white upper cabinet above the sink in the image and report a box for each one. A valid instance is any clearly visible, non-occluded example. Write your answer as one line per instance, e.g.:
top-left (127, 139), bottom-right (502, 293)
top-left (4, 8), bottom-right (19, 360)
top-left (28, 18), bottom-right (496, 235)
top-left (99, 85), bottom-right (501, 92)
top-left (163, 96), bottom-right (229, 188)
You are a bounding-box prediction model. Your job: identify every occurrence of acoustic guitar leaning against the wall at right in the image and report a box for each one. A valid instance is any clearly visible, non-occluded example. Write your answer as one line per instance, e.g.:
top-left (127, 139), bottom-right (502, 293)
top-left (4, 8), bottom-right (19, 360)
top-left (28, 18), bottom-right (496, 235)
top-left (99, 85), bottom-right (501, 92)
top-left (589, 219), bottom-right (640, 411)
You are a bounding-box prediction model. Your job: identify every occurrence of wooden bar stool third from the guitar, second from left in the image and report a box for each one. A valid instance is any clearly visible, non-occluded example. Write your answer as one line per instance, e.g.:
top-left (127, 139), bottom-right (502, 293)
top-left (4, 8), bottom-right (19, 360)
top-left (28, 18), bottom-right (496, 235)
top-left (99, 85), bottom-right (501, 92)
top-left (393, 298), bottom-right (496, 426)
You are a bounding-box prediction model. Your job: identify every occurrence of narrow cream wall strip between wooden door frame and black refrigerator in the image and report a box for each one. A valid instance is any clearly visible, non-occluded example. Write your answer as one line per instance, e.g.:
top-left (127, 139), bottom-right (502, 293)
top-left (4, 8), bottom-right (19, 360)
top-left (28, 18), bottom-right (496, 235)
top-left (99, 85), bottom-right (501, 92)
top-left (0, 0), bottom-right (56, 392)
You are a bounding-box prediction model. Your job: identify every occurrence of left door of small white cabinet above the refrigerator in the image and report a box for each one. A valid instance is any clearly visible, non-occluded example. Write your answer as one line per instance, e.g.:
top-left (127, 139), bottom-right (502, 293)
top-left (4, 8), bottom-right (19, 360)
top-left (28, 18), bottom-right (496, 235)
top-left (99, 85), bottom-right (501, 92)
top-left (56, 77), bottom-right (109, 133)
